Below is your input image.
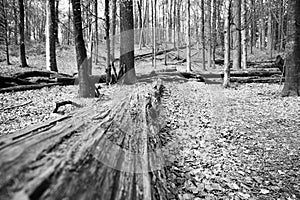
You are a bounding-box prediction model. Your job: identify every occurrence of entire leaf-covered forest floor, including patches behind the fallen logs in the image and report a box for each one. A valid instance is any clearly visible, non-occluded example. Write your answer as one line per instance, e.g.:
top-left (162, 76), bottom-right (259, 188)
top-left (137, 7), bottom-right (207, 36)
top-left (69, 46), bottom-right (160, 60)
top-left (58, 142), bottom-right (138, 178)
top-left (0, 43), bottom-right (300, 200)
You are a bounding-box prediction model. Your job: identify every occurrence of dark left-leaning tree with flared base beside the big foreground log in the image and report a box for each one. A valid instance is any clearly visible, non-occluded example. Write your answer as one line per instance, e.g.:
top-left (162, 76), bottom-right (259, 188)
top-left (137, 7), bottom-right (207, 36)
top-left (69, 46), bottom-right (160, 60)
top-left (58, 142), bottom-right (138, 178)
top-left (72, 0), bottom-right (95, 97)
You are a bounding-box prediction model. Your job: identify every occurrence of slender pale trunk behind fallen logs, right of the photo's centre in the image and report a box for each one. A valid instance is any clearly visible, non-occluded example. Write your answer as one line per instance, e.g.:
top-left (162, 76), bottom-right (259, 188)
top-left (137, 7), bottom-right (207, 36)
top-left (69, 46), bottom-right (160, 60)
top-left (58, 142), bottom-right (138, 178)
top-left (186, 0), bottom-right (192, 72)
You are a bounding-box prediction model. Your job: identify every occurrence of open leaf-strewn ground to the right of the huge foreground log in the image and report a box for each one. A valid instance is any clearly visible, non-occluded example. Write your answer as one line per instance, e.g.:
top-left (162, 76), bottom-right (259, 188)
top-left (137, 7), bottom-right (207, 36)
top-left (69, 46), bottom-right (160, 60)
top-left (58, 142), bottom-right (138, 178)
top-left (167, 81), bottom-right (300, 200)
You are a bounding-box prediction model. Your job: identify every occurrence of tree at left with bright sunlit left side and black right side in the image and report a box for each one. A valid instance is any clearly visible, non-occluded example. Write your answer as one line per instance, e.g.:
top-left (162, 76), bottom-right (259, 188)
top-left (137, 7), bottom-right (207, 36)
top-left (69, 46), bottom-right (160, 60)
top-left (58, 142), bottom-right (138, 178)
top-left (46, 0), bottom-right (58, 72)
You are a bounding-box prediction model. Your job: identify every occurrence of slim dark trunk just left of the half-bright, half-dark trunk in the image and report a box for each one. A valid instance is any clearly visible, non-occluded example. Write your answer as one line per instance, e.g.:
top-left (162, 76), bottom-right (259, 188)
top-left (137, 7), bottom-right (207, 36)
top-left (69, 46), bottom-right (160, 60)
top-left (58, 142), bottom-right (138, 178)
top-left (19, 0), bottom-right (28, 67)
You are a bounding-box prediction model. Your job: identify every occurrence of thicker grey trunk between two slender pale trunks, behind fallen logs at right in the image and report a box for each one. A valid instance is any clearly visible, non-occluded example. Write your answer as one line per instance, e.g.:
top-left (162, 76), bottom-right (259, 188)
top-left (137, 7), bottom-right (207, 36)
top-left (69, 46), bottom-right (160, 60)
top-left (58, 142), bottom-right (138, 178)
top-left (232, 0), bottom-right (242, 70)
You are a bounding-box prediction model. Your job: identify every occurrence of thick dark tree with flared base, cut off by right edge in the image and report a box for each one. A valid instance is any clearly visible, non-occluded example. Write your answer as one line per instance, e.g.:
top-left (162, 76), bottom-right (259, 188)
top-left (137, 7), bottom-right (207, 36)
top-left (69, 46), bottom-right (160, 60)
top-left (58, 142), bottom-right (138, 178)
top-left (281, 0), bottom-right (300, 96)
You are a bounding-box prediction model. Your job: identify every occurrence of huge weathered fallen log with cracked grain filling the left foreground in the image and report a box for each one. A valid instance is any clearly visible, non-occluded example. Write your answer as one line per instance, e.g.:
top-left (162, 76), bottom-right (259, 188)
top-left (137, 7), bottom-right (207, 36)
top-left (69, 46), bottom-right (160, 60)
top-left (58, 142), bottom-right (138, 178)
top-left (0, 81), bottom-right (168, 200)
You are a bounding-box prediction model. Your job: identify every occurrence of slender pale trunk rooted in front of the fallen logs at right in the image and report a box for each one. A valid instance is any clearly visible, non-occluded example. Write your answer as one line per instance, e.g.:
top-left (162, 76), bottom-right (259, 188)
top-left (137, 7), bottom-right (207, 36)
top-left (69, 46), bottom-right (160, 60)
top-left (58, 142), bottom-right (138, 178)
top-left (223, 0), bottom-right (231, 88)
